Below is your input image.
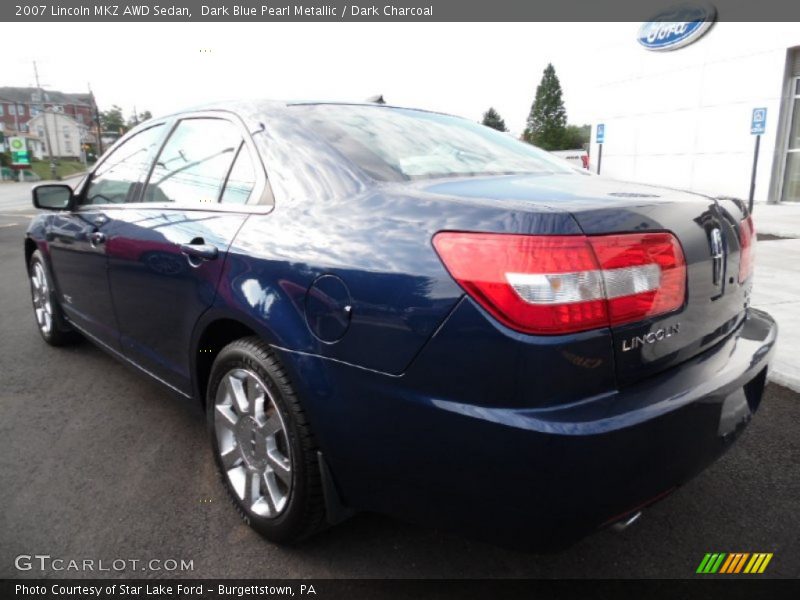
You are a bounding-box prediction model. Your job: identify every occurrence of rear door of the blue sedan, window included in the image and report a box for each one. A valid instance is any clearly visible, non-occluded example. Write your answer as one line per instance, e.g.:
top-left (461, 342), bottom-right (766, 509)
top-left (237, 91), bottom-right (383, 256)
top-left (101, 113), bottom-right (266, 393)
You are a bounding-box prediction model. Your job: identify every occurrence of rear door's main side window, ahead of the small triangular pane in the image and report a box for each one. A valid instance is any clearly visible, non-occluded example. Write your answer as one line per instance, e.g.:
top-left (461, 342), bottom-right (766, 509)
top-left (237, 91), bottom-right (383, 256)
top-left (143, 119), bottom-right (242, 204)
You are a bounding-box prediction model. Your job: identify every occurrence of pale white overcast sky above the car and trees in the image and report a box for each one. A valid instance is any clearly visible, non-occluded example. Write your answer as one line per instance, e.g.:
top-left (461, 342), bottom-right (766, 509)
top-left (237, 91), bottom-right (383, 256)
top-left (0, 23), bottom-right (638, 133)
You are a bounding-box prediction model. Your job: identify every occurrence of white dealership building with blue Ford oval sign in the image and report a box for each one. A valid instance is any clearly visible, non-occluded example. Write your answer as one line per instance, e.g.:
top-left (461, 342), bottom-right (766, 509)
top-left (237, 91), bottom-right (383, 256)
top-left (587, 21), bottom-right (800, 203)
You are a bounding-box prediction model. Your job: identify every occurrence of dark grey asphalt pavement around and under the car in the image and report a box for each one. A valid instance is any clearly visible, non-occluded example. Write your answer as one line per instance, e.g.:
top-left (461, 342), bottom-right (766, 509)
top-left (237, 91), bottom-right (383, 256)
top-left (0, 199), bottom-right (800, 578)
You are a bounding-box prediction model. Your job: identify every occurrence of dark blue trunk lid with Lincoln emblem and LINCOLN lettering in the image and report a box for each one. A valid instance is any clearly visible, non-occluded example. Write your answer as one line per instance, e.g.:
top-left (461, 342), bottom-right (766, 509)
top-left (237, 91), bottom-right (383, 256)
top-left (426, 175), bottom-right (752, 387)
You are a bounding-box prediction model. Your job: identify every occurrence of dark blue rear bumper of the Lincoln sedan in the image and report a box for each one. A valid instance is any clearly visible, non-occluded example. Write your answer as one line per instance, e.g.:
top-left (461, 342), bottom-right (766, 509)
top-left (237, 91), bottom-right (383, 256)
top-left (280, 310), bottom-right (777, 550)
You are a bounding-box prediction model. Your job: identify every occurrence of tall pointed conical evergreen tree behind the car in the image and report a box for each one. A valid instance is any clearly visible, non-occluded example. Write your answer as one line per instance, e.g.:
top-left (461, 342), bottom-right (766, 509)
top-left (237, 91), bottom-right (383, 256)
top-left (522, 63), bottom-right (567, 150)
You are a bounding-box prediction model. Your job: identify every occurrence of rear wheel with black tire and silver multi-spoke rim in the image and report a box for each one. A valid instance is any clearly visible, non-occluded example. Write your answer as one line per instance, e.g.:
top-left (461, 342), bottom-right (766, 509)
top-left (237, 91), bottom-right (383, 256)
top-left (206, 337), bottom-right (325, 544)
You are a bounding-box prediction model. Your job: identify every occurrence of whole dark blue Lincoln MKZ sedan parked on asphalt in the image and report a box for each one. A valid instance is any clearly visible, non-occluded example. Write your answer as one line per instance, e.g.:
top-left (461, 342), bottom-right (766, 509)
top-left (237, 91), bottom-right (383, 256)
top-left (25, 102), bottom-right (777, 550)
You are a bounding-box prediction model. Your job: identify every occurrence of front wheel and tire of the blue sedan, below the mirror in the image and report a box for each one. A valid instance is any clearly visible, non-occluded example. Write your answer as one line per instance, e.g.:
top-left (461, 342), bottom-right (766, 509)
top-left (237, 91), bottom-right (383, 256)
top-left (28, 250), bottom-right (80, 346)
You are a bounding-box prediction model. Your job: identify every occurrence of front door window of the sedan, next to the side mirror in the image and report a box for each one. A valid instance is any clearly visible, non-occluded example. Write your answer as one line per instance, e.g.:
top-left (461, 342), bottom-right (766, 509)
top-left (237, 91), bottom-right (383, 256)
top-left (81, 125), bottom-right (163, 204)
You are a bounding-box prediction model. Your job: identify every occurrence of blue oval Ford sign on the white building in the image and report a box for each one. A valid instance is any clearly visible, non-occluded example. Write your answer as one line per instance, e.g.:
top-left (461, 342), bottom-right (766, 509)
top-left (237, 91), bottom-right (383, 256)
top-left (637, 3), bottom-right (717, 51)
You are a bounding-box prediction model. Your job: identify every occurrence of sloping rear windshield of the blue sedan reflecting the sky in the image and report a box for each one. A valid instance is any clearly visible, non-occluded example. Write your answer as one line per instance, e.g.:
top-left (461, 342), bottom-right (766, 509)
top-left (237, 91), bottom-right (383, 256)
top-left (291, 104), bottom-right (572, 181)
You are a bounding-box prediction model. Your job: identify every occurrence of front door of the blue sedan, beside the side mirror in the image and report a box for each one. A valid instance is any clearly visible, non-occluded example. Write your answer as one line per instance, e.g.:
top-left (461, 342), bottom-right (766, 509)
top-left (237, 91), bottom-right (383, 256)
top-left (47, 123), bottom-right (166, 350)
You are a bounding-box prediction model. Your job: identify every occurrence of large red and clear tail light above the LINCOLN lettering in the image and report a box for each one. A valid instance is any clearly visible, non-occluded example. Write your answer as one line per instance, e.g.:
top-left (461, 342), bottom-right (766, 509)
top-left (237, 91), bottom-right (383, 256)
top-left (433, 231), bottom-right (686, 335)
